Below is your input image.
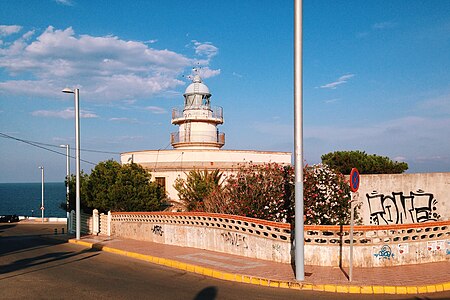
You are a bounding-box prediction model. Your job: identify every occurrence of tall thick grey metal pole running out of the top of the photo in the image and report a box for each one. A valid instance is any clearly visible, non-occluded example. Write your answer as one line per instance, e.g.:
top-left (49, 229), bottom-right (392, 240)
top-left (294, 0), bottom-right (305, 281)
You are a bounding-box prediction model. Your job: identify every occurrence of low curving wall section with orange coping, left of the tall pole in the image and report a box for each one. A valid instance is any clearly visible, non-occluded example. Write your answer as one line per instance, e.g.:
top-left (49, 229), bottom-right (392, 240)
top-left (111, 213), bottom-right (291, 263)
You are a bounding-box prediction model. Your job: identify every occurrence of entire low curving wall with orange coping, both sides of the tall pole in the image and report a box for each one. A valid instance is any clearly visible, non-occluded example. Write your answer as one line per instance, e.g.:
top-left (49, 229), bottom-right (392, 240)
top-left (106, 212), bottom-right (450, 267)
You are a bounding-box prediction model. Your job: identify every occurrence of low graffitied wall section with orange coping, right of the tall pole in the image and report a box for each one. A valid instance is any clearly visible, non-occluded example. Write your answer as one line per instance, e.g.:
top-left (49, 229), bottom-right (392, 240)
top-left (305, 221), bottom-right (450, 268)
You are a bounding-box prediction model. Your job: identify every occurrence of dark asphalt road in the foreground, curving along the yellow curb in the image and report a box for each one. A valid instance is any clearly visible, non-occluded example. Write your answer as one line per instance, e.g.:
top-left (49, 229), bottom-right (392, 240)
top-left (0, 223), bottom-right (450, 300)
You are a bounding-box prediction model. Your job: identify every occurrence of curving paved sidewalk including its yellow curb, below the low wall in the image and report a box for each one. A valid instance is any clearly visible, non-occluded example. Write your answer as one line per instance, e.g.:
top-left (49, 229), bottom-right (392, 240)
top-left (69, 236), bottom-right (450, 294)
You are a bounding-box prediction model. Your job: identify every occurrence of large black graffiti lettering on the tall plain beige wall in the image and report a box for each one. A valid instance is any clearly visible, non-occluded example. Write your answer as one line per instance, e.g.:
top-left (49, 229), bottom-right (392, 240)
top-left (366, 190), bottom-right (441, 225)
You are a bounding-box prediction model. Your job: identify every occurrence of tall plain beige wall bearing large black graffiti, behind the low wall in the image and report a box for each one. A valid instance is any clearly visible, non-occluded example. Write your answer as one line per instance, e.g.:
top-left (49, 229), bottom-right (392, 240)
top-left (356, 173), bottom-right (450, 225)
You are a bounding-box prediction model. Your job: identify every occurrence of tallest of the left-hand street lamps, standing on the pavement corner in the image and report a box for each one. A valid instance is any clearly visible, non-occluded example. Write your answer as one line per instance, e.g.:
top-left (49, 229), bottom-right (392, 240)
top-left (62, 88), bottom-right (81, 240)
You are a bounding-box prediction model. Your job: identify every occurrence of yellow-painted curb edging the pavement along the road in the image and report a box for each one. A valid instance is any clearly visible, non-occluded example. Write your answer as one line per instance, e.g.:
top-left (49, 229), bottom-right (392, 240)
top-left (68, 239), bottom-right (450, 295)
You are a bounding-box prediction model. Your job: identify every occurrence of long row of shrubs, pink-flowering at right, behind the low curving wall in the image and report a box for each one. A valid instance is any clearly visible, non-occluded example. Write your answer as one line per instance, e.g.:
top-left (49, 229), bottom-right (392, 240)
top-left (175, 163), bottom-right (358, 225)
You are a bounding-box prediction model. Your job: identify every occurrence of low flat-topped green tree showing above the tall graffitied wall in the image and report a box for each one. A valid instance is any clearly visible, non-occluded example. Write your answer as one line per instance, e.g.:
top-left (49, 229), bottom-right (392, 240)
top-left (321, 151), bottom-right (408, 174)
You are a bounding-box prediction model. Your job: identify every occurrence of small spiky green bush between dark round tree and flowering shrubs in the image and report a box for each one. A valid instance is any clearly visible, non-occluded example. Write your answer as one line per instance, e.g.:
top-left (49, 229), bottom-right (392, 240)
top-left (174, 169), bottom-right (223, 211)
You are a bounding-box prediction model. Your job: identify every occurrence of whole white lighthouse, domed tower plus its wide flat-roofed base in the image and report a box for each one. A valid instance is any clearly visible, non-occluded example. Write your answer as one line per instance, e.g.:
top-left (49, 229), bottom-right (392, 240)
top-left (120, 75), bottom-right (291, 209)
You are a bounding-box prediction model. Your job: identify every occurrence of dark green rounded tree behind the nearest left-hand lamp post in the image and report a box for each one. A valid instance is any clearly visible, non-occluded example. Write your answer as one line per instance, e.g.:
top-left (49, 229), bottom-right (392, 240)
top-left (64, 160), bottom-right (166, 212)
